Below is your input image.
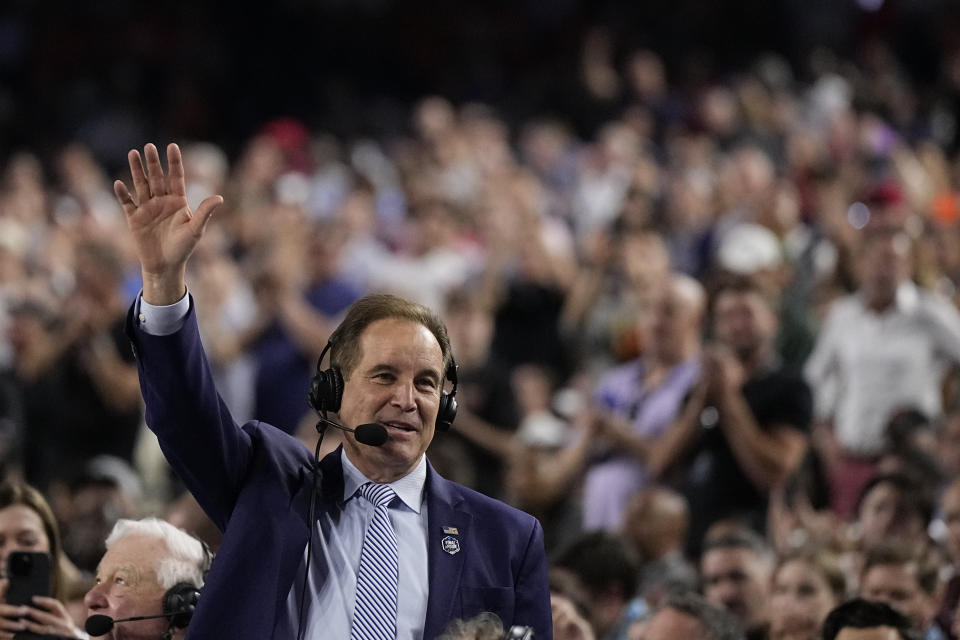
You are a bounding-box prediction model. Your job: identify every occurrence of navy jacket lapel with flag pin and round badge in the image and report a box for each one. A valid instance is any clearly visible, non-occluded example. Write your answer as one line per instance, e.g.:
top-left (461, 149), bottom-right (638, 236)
top-left (423, 462), bottom-right (473, 638)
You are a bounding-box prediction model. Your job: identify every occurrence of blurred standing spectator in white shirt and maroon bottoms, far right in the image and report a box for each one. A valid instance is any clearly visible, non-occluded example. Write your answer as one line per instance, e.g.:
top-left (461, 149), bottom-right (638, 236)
top-left (805, 228), bottom-right (960, 518)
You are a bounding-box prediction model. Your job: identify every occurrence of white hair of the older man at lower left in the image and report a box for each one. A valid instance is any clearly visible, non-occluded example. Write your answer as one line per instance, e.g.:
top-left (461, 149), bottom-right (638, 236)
top-left (106, 518), bottom-right (210, 589)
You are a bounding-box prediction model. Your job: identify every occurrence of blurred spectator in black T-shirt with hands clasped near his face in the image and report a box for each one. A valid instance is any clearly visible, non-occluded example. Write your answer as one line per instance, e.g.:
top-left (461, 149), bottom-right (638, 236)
top-left (649, 280), bottom-right (811, 557)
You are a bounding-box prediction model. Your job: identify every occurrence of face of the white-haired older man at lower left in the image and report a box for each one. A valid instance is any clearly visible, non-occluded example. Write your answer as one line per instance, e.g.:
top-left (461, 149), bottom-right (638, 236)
top-left (83, 534), bottom-right (168, 640)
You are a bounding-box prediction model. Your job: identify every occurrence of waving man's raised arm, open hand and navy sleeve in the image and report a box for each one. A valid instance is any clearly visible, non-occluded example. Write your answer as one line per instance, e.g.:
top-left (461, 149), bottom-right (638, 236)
top-left (114, 144), bottom-right (251, 530)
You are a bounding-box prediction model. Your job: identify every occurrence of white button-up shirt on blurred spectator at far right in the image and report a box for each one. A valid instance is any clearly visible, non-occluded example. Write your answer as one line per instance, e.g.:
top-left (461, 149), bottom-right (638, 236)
top-left (804, 282), bottom-right (960, 457)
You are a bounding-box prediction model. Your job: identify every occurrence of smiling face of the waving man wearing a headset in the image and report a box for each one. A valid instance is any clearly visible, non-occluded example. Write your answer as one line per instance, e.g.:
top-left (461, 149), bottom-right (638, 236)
top-left (339, 318), bottom-right (444, 482)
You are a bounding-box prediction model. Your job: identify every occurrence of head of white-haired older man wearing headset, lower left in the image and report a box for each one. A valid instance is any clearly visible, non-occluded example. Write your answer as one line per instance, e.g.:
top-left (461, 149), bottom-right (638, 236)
top-left (84, 518), bottom-right (210, 640)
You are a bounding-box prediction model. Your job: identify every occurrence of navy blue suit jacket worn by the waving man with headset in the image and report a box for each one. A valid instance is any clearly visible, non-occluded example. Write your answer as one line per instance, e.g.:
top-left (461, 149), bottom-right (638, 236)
top-left (128, 300), bottom-right (553, 640)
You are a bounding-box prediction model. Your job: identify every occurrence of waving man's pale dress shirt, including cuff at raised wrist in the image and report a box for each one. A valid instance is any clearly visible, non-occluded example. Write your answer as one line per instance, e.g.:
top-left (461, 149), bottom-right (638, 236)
top-left (135, 295), bottom-right (429, 640)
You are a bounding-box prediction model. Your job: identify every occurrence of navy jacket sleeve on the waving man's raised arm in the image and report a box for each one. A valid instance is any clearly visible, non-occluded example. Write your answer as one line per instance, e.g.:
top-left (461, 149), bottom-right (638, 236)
top-left (127, 298), bottom-right (251, 531)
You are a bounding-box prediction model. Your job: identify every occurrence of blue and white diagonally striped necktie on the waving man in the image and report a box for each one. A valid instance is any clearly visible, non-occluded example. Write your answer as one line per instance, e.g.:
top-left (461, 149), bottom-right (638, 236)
top-left (350, 482), bottom-right (399, 640)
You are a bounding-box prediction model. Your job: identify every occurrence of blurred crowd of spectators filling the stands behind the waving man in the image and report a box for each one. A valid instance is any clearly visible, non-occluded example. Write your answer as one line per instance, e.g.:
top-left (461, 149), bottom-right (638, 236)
top-left (0, 35), bottom-right (960, 639)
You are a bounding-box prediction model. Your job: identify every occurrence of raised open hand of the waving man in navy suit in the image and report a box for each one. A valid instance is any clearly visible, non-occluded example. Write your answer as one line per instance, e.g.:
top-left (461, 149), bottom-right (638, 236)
top-left (113, 143), bottom-right (223, 305)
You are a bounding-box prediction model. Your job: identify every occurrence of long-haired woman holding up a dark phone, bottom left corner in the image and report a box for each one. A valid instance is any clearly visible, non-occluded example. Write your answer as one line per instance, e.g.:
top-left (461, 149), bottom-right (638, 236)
top-left (0, 481), bottom-right (87, 640)
